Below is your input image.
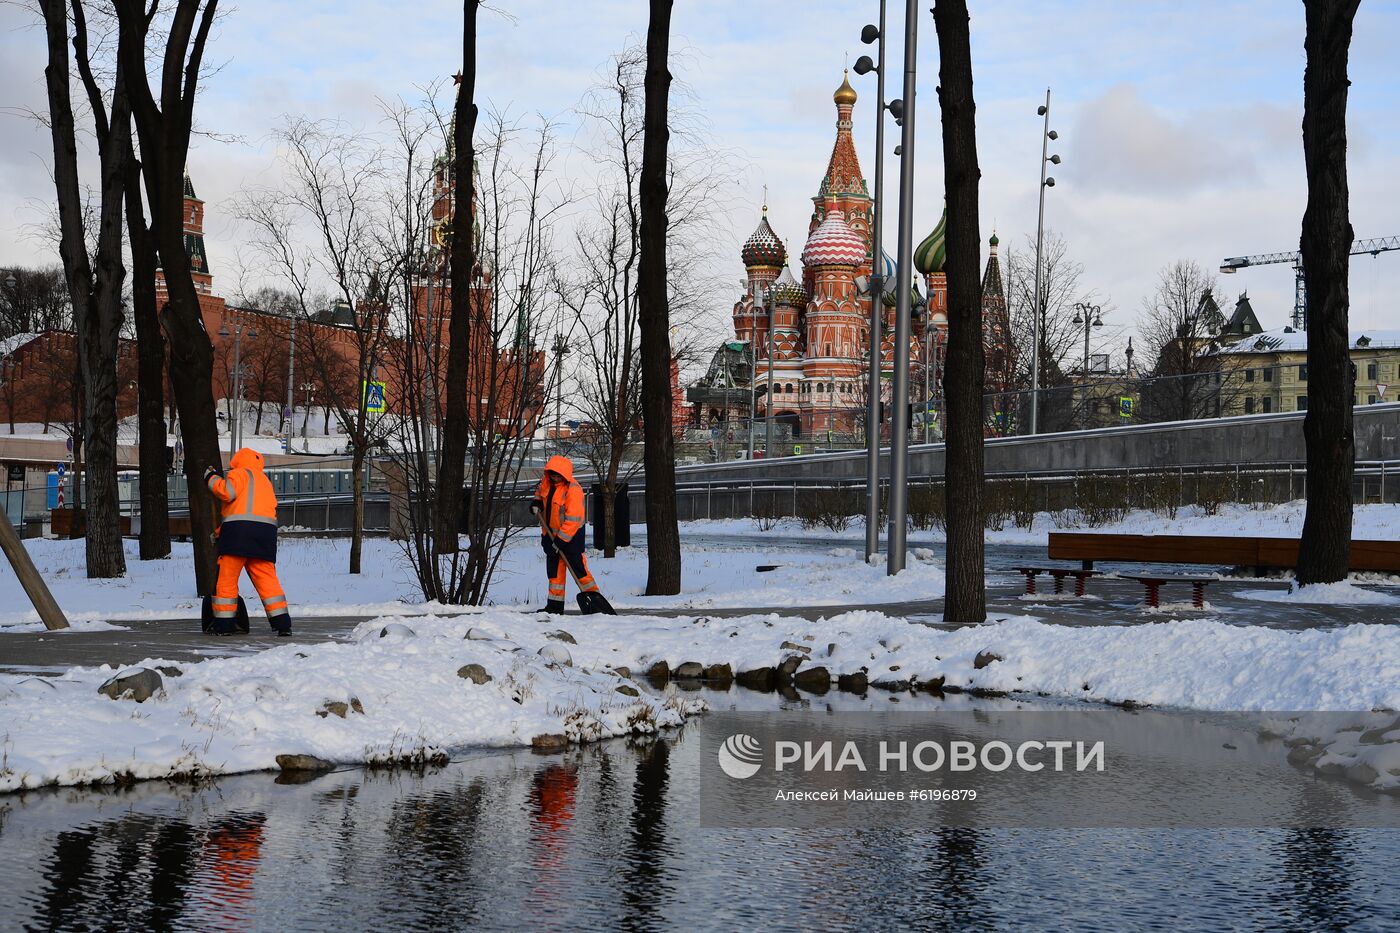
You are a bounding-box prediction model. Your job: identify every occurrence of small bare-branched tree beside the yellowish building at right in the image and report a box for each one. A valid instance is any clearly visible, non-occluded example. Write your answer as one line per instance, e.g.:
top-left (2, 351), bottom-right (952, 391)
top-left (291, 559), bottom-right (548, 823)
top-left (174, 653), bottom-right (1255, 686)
top-left (1138, 259), bottom-right (1226, 422)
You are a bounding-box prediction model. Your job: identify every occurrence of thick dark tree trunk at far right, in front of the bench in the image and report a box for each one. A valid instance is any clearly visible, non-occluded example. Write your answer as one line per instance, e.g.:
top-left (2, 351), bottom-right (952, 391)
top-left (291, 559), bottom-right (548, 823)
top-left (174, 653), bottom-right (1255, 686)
top-left (1298, 0), bottom-right (1359, 584)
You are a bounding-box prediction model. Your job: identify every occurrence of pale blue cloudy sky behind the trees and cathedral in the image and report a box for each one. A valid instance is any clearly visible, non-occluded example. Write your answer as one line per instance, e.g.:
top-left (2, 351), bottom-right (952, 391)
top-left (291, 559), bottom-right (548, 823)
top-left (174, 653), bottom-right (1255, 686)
top-left (0, 0), bottom-right (1400, 358)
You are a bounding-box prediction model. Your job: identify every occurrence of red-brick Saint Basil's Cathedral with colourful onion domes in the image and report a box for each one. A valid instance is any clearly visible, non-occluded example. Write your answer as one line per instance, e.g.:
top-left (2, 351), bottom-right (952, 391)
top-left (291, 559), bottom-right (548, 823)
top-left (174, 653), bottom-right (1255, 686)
top-left (687, 70), bottom-right (1015, 443)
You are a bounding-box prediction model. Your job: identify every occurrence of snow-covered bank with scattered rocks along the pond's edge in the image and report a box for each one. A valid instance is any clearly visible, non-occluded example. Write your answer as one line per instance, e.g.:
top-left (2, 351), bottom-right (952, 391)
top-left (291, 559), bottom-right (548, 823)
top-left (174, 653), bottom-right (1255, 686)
top-left (0, 608), bottom-right (1400, 790)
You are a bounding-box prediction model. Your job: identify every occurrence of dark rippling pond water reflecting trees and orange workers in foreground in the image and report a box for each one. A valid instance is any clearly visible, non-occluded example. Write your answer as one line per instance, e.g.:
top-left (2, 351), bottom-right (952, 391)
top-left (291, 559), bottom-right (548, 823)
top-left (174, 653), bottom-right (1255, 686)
top-left (0, 691), bottom-right (1400, 932)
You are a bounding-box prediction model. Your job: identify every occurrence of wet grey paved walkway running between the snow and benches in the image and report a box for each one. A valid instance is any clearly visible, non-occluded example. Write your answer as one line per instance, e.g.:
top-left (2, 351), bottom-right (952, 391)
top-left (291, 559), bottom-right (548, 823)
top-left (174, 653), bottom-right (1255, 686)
top-left (0, 573), bottom-right (1400, 674)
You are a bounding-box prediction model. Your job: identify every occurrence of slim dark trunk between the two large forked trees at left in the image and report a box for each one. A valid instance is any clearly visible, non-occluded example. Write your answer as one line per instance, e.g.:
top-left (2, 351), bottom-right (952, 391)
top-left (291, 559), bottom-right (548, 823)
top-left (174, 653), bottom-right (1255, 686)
top-left (126, 146), bottom-right (171, 560)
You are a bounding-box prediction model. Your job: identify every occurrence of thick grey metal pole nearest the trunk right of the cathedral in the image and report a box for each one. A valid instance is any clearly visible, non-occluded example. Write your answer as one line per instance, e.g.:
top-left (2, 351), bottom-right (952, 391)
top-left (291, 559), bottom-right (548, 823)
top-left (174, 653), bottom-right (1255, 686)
top-left (886, 0), bottom-right (918, 574)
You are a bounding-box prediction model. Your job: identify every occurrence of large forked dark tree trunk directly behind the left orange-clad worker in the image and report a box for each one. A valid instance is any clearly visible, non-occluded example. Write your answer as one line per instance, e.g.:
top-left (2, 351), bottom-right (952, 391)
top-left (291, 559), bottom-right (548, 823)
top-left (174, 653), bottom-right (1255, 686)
top-left (116, 0), bottom-right (223, 595)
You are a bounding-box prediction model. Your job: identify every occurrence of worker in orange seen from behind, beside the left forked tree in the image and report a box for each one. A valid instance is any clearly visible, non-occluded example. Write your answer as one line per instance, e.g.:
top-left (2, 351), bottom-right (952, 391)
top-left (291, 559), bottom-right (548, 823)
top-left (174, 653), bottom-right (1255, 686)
top-left (204, 447), bottom-right (291, 635)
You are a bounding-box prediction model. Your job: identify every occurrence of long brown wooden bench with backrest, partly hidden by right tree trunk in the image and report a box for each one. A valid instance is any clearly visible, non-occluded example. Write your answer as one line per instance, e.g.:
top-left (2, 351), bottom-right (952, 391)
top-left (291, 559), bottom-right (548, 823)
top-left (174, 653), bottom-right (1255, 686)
top-left (1049, 531), bottom-right (1400, 573)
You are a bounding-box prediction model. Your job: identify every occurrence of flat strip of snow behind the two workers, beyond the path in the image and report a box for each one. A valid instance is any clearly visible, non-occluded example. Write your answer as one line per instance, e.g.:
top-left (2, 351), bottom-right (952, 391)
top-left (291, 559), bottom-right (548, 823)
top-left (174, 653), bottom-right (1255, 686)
top-left (0, 534), bottom-right (944, 633)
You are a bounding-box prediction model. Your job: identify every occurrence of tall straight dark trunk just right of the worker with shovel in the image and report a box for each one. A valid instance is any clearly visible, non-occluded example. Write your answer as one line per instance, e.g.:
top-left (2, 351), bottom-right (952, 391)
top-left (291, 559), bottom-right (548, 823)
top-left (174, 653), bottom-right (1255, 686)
top-left (637, 0), bottom-right (680, 595)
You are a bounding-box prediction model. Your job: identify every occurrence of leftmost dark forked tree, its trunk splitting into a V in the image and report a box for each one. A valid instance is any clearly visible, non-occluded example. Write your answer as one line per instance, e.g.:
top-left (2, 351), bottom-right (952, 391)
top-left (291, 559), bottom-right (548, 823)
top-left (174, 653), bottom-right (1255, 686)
top-left (43, 0), bottom-right (132, 577)
